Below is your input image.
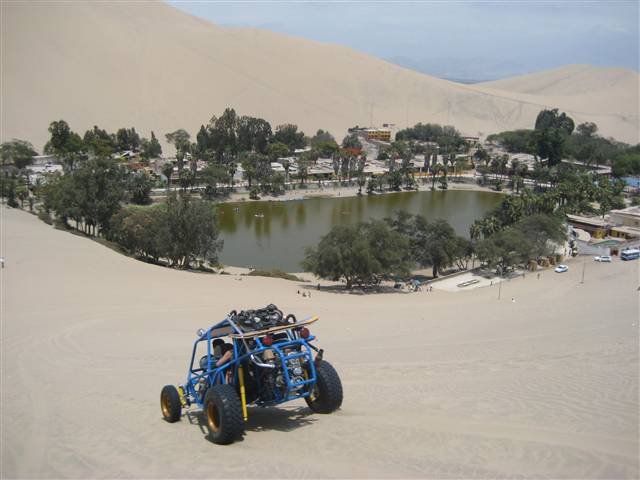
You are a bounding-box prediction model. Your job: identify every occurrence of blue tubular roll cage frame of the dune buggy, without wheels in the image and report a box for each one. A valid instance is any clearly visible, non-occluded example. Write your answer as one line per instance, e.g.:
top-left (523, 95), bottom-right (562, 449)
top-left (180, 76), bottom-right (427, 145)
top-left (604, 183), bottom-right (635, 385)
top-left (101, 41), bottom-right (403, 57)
top-left (179, 315), bottom-right (322, 407)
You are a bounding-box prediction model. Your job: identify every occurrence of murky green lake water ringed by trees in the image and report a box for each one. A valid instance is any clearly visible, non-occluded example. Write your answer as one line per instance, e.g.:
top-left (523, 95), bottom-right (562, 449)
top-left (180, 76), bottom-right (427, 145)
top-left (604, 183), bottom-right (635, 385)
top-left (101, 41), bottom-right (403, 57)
top-left (219, 190), bottom-right (501, 272)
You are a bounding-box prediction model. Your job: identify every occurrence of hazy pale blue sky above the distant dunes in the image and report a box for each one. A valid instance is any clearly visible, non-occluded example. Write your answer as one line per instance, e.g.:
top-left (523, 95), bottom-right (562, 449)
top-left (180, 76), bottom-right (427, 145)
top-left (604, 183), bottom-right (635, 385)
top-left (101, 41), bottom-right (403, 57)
top-left (168, 0), bottom-right (640, 81)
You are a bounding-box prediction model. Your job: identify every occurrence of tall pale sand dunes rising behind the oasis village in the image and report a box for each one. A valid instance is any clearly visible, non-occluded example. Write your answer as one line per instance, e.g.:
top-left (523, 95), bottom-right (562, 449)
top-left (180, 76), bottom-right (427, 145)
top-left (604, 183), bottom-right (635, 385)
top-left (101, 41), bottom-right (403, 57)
top-left (0, 2), bottom-right (640, 148)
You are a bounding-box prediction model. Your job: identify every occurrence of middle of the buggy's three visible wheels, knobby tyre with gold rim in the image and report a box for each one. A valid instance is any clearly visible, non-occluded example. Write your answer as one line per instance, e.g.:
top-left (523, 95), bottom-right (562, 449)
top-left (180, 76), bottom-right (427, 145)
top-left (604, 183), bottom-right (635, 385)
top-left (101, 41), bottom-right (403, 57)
top-left (203, 384), bottom-right (244, 445)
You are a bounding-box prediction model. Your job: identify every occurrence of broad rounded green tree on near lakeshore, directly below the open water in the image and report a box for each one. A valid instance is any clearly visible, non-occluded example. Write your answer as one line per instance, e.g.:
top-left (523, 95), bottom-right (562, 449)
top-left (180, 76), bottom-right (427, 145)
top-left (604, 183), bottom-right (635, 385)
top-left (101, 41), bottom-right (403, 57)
top-left (303, 221), bottom-right (409, 289)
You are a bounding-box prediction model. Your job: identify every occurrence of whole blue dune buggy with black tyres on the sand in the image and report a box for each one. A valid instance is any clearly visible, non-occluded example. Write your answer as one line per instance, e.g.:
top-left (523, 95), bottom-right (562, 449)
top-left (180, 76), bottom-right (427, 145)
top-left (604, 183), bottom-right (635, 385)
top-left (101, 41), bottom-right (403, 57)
top-left (160, 305), bottom-right (342, 445)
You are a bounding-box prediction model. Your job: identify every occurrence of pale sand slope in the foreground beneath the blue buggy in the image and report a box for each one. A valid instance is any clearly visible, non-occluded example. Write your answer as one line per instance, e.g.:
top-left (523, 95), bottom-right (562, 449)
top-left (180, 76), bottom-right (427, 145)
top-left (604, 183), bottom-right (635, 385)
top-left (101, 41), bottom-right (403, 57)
top-left (0, 207), bottom-right (640, 478)
